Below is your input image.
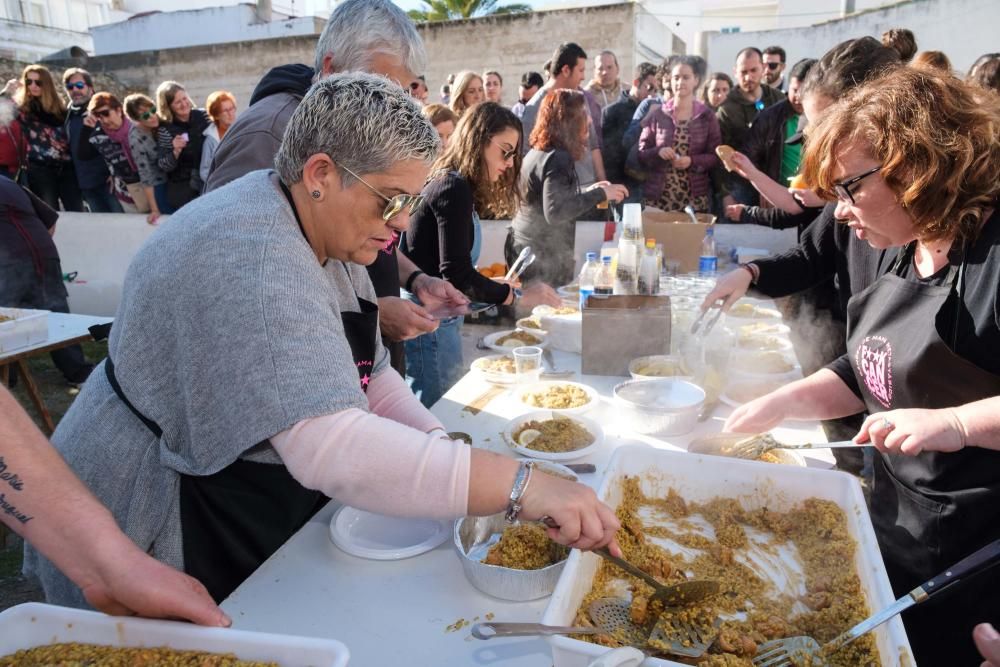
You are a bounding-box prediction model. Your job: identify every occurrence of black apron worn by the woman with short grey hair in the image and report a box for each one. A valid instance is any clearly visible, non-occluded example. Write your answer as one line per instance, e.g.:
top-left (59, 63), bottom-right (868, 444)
top-left (105, 187), bottom-right (378, 602)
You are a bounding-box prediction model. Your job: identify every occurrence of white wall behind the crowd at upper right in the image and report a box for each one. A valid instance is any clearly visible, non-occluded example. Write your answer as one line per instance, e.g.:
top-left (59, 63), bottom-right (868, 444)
top-left (708, 0), bottom-right (1000, 72)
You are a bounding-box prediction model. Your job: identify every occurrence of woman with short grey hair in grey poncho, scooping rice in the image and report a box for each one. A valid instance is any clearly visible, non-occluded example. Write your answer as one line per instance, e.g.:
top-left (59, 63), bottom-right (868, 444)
top-left (26, 73), bottom-right (619, 606)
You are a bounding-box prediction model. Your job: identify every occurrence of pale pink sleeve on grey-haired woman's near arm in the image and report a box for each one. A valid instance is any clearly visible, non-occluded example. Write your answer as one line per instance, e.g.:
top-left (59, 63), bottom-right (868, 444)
top-left (271, 408), bottom-right (471, 519)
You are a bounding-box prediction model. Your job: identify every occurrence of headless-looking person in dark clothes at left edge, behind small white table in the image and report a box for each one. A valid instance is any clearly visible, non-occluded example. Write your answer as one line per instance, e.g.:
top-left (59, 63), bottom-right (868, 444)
top-left (0, 177), bottom-right (92, 385)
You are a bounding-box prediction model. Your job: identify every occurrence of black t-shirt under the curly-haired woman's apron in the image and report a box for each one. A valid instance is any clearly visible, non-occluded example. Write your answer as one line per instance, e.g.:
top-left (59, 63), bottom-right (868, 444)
top-left (827, 210), bottom-right (1000, 397)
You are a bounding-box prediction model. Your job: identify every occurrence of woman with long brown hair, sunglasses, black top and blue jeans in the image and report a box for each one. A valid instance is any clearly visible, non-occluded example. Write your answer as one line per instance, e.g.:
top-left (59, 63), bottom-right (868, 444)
top-left (400, 102), bottom-right (560, 407)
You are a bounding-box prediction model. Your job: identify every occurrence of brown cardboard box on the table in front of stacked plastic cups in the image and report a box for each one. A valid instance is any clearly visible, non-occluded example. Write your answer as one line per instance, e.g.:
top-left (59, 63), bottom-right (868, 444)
top-left (581, 296), bottom-right (670, 377)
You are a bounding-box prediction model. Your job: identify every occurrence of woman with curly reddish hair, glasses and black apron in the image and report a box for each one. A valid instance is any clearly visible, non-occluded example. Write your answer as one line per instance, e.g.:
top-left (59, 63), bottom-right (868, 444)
top-left (726, 67), bottom-right (1000, 665)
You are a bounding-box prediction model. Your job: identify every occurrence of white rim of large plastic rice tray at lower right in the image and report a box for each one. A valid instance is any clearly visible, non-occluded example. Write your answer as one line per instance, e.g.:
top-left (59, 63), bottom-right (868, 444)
top-left (541, 446), bottom-right (915, 667)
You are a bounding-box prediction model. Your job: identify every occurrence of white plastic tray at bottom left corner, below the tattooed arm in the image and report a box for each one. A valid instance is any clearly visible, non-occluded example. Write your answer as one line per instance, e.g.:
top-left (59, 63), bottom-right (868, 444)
top-left (0, 602), bottom-right (350, 667)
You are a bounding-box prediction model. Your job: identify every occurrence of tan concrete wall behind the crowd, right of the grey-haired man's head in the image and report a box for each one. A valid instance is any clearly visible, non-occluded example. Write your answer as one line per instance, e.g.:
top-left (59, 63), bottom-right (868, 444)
top-left (417, 3), bottom-right (674, 105)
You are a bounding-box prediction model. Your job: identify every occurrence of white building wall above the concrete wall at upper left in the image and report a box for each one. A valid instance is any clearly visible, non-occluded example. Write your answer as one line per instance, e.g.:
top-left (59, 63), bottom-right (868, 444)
top-left (91, 4), bottom-right (326, 56)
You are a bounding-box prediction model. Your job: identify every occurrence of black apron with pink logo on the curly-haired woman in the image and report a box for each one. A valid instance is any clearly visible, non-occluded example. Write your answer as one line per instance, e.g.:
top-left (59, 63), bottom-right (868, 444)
top-left (847, 246), bottom-right (1000, 667)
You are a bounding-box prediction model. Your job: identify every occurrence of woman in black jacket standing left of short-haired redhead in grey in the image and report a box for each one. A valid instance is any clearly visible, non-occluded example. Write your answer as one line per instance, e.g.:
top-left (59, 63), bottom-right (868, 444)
top-left (156, 81), bottom-right (211, 209)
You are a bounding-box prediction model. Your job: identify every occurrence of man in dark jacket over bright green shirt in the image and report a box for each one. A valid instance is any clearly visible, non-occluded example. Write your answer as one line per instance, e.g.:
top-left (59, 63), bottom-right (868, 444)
top-left (743, 58), bottom-right (816, 204)
